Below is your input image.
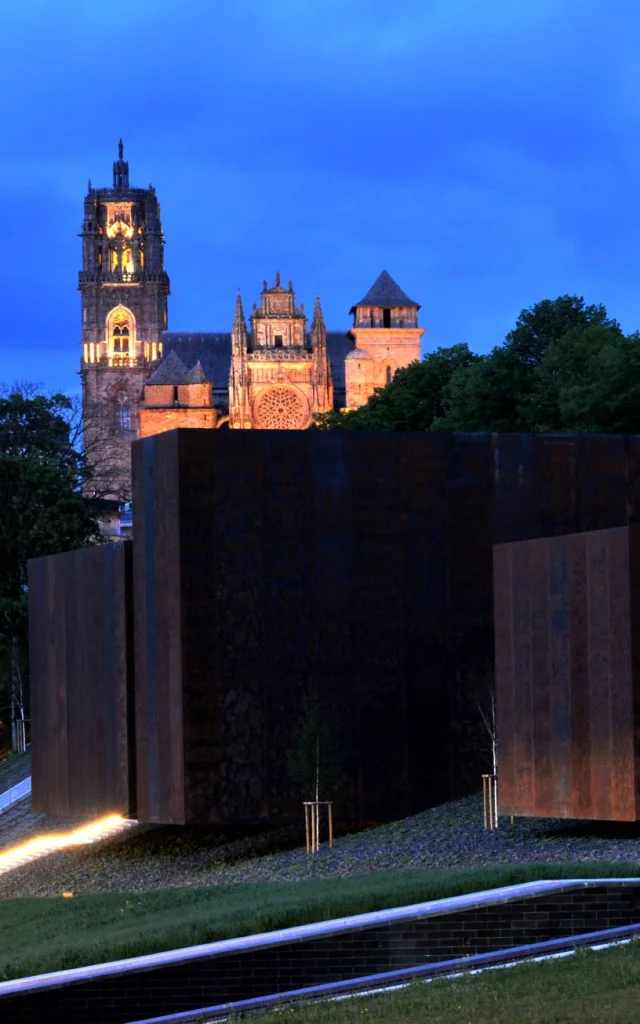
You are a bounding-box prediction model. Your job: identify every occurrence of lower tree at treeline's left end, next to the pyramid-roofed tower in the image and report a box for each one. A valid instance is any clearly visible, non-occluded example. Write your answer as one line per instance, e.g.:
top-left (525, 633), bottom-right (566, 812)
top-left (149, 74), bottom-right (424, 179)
top-left (316, 344), bottom-right (480, 430)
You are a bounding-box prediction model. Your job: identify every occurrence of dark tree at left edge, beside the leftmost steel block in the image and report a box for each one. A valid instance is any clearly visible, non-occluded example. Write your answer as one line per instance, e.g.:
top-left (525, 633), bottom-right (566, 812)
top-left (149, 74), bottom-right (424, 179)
top-left (0, 386), bottom-right (99, 749)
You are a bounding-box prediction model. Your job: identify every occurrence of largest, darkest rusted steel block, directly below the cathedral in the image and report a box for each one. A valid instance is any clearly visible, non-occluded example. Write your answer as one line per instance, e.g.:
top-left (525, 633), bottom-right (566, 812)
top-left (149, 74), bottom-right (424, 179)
top-left (133, 431), bottom-right (640, 823)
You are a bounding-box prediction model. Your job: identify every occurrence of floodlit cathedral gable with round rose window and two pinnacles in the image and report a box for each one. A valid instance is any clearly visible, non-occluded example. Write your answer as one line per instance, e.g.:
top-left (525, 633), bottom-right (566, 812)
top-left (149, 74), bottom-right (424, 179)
top-left (229, 273), bottom-right (334, 430)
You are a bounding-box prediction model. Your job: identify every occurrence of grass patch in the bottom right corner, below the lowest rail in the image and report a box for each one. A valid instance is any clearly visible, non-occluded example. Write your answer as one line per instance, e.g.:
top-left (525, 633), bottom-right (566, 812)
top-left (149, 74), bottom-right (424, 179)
top-left (238, 940), bottom-right (640, 1024)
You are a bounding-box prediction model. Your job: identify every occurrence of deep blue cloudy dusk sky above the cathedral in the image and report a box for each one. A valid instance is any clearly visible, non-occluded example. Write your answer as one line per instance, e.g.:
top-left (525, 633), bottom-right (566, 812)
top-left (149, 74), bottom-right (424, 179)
top-left (0, 0), bottom-right (640, 391)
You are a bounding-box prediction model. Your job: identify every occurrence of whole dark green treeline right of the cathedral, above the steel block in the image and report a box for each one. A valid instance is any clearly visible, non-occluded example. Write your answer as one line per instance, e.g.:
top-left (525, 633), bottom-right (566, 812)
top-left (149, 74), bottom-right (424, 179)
top-left (315, 295), bottom-right (640, 433)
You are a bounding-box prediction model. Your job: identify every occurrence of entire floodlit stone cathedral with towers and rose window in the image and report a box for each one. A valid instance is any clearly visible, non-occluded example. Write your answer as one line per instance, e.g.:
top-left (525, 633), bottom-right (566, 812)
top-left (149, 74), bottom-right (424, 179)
top-left (78, 140), bottom-right (424, 512)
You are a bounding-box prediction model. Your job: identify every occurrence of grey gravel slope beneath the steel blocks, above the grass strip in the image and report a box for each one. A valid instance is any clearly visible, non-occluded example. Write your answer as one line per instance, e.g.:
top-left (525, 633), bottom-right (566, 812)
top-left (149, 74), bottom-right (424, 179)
top-left (0, 797), bottom-right (640, 897)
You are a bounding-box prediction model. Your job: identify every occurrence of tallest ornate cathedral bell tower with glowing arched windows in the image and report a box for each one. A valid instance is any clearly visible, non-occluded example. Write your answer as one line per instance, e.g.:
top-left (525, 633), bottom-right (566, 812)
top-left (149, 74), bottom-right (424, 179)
top-left (78, 139), bottom-right (169, 501)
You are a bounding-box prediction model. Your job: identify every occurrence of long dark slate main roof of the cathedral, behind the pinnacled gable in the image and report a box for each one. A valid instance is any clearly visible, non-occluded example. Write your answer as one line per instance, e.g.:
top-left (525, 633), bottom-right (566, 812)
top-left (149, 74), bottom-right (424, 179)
top-left (158, 331), bottom-right (353, 403)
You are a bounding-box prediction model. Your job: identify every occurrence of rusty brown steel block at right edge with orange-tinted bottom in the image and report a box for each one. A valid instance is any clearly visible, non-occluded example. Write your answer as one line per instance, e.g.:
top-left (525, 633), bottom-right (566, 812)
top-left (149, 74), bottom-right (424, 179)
top-left (494, 526), bottom-right (640, 821)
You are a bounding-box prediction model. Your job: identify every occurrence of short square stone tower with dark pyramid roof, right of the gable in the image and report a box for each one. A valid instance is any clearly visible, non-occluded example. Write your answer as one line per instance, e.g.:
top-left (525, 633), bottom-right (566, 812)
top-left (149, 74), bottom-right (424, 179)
top-left (345, 270), bottom-right (425, 409)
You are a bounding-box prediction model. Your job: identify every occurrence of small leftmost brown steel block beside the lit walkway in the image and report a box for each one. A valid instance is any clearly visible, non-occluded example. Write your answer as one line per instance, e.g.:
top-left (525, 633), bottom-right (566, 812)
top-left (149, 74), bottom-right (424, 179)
top-left (29, 543), bottom-right (135, 815)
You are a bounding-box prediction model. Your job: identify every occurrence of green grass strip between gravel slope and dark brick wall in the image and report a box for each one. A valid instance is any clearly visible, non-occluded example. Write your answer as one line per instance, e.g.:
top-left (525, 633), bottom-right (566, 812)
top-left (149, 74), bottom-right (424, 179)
top-left (0, 862), bottom-right (640, 983)
